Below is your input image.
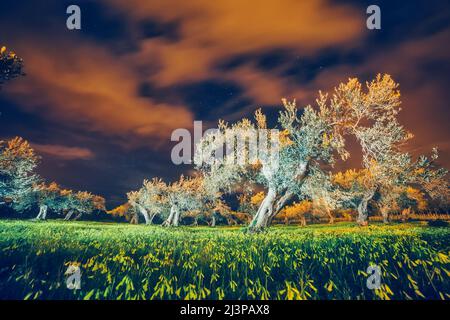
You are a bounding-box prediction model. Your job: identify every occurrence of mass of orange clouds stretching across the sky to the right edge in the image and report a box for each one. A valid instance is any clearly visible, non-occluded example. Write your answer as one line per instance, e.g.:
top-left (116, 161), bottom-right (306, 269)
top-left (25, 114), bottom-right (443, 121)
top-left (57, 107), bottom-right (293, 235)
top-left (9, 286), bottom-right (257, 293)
top-left (1, 0), bottom-right (450, 172)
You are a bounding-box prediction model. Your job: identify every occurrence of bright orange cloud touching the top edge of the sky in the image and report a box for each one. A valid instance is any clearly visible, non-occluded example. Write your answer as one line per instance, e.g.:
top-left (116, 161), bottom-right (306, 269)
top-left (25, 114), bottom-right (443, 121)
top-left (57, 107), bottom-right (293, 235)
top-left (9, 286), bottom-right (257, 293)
top-left (113, 0), bottom-right (365, 86)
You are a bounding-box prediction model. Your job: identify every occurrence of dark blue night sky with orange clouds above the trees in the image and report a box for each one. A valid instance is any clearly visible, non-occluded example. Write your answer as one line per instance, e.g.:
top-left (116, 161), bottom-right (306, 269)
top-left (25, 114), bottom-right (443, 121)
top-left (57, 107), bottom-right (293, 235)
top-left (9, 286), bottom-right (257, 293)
top-left (0, 0), bottom-right (450, 207)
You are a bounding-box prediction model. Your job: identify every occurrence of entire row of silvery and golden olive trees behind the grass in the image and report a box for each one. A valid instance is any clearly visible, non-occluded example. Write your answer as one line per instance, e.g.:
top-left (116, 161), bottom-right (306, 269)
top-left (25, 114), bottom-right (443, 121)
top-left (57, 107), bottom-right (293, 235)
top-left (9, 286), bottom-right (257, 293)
top-left (0, 48), bottom-right (449, 231)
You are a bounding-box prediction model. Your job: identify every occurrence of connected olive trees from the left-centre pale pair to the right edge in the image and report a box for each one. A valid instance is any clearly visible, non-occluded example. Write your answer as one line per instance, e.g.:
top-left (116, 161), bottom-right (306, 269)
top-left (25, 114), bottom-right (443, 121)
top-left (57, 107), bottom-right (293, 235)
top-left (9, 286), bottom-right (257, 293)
top-left (124, 75), bottom-right (448, 231)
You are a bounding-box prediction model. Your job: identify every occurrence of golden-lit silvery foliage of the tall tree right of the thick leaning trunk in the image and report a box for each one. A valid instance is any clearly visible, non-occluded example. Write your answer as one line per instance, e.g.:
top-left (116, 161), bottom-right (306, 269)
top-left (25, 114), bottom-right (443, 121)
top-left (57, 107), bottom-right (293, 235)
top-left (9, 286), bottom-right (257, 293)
top-left (339, 75), bottom-right (448, 216)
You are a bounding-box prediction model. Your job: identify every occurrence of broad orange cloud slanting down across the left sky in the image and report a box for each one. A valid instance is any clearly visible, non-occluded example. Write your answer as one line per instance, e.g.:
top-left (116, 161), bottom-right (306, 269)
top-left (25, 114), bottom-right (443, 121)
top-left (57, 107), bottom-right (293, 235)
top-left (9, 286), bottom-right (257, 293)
top-left (6, 39), bottom-right (192, 144)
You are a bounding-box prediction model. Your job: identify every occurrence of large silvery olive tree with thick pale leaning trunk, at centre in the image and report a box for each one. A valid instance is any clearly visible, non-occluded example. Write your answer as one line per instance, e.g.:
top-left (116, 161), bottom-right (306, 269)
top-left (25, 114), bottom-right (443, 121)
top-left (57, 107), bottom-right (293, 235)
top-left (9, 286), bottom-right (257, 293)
top-left (198, 87), bottom-right (348, 231)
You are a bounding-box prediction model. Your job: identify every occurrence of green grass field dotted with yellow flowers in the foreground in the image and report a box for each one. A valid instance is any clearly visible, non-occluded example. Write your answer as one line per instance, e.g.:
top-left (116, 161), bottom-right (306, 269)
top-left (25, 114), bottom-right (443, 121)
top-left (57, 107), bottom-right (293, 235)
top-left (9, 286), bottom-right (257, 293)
top-left (0, 220), bottom-right (450, 299)
